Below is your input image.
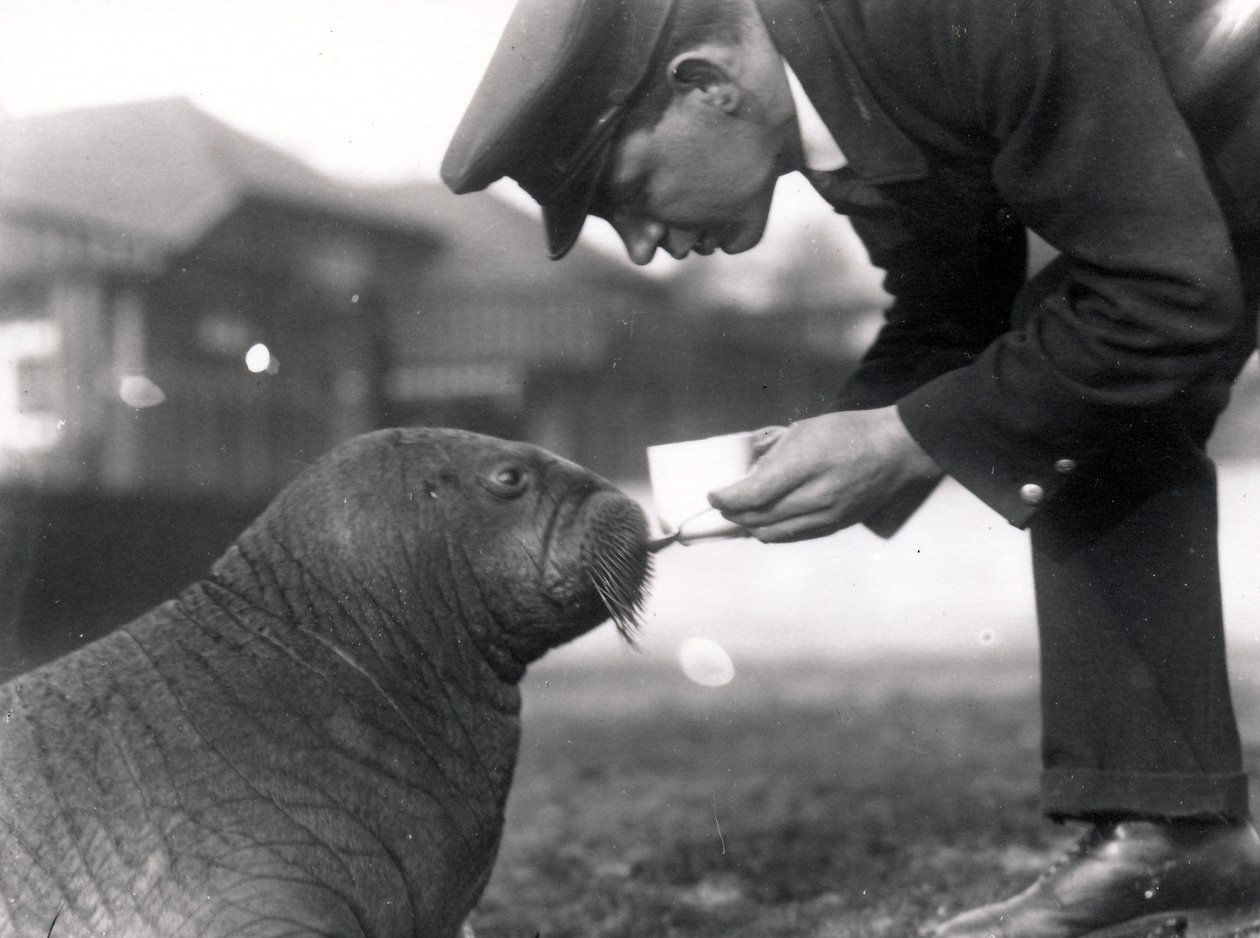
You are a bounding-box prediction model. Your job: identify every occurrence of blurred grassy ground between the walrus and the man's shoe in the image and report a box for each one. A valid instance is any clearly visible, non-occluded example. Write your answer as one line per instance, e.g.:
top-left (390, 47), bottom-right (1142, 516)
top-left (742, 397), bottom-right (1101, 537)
top-left (473, 657), bottom-right (1260, 938)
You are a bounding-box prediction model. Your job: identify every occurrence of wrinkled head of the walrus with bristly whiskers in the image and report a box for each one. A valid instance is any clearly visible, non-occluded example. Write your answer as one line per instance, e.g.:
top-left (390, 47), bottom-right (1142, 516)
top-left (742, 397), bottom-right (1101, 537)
top-left (228, 429), bottom-right (650, 681)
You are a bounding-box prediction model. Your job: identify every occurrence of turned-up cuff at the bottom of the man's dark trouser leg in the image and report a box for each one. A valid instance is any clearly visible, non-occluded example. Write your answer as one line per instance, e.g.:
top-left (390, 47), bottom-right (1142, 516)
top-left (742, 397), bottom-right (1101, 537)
top-left (1041, 769), bottom-right (1247, 819)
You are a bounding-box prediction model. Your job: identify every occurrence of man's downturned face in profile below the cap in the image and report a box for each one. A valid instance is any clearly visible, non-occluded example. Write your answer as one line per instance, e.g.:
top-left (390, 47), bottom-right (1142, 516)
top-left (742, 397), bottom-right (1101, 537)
top-left (599, 88), bottom-right (784, 265)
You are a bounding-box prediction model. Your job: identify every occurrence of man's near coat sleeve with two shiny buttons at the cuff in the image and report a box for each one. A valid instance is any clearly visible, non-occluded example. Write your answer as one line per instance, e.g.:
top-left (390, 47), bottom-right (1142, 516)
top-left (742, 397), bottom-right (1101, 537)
top-left (892, 0), bottom-right (1242, 527)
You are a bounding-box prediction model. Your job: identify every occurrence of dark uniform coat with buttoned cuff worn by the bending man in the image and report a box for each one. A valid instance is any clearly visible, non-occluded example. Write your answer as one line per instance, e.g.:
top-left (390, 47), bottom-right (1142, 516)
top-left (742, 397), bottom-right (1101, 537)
top-left (759, 0), bottom-right (1260, 526)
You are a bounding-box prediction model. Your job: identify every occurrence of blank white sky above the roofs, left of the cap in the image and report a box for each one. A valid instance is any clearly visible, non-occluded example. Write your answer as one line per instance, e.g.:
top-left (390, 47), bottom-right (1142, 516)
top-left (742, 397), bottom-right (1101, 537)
top-left (0, 0), bottom-right (512, 180)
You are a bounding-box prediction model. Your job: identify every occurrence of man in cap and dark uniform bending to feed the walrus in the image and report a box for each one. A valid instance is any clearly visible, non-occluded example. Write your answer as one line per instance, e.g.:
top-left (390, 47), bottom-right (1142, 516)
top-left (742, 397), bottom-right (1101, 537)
top-left (442, 0), bottom-right (1260, 938)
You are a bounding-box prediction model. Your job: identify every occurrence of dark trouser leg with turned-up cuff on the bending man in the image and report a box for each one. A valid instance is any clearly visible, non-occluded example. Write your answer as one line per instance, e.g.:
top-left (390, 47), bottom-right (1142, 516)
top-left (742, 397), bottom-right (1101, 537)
top-left (1022, 238), bottom-right (1260, 819)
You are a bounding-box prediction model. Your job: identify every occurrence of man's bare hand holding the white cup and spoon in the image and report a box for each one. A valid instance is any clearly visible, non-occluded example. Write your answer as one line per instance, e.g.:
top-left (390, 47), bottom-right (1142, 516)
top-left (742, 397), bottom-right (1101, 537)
top-left (709, 407), bottom-right (941, 542)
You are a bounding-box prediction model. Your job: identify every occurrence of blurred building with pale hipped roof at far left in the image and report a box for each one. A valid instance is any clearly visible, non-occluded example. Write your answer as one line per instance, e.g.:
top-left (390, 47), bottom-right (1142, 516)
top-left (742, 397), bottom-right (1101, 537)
top-left (0, 100), bottom-right (437, 495)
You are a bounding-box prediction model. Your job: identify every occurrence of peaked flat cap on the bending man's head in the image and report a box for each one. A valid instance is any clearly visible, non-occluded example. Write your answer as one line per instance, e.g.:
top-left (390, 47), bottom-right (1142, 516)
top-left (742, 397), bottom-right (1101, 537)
top-left (442, 0), bottom-right (677, 258)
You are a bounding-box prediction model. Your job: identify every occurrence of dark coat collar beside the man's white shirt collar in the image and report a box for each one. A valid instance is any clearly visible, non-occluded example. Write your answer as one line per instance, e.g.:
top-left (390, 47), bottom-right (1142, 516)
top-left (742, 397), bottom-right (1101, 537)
top-left (756, 0), bottom-right (927, 184)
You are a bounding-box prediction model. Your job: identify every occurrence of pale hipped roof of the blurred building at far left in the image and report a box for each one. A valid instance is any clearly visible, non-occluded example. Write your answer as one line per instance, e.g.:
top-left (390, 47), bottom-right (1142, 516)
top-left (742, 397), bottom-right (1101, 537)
top-left (0, 98), bottom-right (433, 250)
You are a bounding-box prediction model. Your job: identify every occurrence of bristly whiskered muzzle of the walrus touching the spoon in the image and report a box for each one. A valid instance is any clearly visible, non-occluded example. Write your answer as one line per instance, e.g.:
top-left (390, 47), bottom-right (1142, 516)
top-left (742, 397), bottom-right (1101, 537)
top-left (582, 498), bottom-right (651, 646)
